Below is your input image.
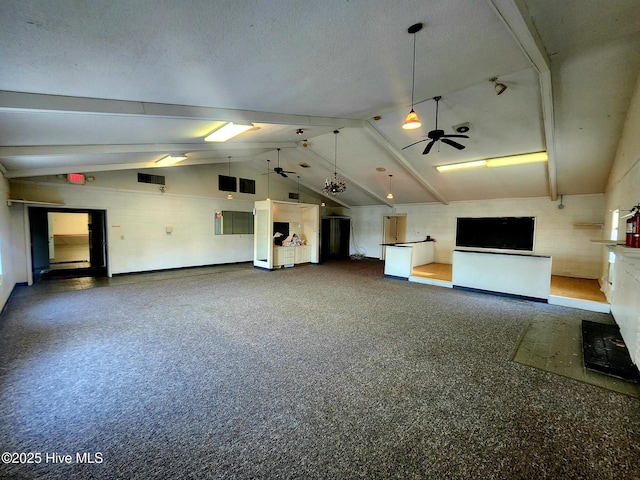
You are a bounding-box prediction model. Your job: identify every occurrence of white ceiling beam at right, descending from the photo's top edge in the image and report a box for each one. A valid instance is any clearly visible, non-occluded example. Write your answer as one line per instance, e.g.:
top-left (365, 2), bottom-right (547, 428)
top-left (487, 0), bottom-right (558, 201)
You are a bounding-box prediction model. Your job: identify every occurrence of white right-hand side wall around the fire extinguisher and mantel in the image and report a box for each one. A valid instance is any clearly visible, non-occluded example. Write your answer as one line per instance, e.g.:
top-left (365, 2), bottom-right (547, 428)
top-left (602, 70), bottom-right (640, 365)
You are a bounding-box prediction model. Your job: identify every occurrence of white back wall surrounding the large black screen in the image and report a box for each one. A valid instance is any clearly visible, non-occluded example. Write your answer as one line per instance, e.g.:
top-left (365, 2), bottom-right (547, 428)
top-left (346, 195), bottom-right (604, 279)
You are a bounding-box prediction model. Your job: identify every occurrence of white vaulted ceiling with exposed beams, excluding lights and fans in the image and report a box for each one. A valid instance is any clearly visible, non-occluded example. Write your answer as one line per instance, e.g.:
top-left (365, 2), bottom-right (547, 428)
top-left (0, 0), bottom-right (640, 206)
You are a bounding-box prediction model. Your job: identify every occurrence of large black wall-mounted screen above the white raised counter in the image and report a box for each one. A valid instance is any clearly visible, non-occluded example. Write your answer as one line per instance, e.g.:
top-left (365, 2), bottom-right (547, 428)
top-left (456, 217), bottom-right (536, 251)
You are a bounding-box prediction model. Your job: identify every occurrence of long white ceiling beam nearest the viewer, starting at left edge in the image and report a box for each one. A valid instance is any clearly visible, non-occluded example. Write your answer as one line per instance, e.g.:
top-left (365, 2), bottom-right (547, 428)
top-left (0, 90), bottom-right (365, 128)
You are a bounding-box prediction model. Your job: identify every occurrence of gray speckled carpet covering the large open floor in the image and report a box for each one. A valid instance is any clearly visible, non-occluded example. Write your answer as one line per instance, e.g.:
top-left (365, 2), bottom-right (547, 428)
top-left (0, 260), bottom-right (640, 479)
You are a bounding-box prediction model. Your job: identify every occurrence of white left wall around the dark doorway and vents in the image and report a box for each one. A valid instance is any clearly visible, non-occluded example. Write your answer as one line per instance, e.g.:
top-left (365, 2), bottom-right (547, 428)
top-left (11, 164), bottom-right (328, 281)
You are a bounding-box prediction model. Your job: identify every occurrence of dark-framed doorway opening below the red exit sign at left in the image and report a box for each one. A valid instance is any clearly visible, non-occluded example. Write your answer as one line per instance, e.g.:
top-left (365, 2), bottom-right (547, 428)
top-left (29, 207), bottom-right (107, 282)
